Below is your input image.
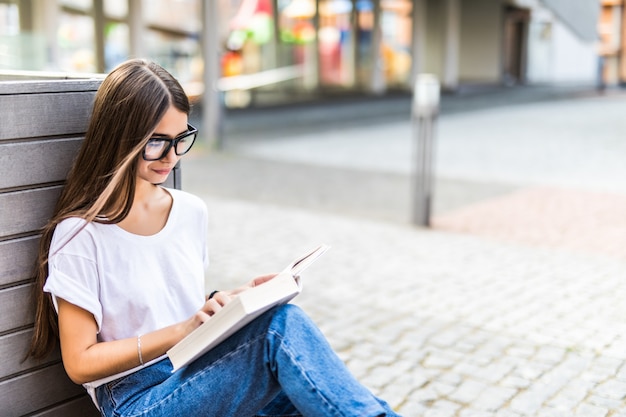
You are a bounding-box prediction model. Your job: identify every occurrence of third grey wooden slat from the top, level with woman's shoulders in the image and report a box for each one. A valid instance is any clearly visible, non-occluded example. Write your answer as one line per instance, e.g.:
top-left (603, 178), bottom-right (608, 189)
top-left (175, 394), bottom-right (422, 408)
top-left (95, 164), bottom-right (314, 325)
top-left (0, 185), bottom-right (61, 237)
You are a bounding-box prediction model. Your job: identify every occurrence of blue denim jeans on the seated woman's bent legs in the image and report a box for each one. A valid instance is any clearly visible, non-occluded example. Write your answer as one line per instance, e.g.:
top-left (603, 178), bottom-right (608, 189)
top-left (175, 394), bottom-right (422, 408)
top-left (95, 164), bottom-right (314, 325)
top-left (96, 304), bottom-right (398, 417)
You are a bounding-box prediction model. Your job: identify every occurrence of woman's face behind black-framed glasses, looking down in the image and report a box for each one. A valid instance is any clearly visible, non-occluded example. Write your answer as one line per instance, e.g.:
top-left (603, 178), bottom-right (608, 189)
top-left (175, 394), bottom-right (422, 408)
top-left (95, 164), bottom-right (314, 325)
top-left (137, 106), bottom-right (187, 184)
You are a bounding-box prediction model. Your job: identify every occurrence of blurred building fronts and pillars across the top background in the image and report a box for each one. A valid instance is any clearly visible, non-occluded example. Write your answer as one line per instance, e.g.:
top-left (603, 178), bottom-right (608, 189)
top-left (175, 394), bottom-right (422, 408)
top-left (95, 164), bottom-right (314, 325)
top-left (0, 0), bottom-right (604, 107)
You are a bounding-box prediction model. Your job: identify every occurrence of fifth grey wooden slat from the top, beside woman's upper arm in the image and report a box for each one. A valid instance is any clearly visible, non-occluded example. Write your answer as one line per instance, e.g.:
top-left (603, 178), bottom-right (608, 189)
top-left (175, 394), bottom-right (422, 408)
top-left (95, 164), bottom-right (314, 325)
top-left (0, 284), bottom-right (35, 333)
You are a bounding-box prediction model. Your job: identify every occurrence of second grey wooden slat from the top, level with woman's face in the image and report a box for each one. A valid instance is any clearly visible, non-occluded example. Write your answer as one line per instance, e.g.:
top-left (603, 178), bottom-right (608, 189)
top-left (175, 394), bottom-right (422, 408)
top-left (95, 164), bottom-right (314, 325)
top-left (0, 137), bottom-right (82, 189)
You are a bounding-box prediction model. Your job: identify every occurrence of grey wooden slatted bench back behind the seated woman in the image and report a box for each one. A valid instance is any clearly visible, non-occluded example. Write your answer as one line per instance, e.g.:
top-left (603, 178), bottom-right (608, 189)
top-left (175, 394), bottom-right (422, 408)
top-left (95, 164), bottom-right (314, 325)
top-left (0, 75), bottom-right (181, 417)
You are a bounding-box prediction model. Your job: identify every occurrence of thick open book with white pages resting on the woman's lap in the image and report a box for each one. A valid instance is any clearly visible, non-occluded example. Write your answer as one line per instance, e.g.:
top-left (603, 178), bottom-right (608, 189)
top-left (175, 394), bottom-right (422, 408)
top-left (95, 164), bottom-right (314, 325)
top-left (167, 245), bottom-right (329, 371)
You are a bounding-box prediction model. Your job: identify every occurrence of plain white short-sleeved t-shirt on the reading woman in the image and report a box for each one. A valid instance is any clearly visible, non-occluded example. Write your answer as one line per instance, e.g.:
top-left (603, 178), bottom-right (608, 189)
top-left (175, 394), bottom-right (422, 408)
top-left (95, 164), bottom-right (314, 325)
top-left (44, 189), bottom-right (208, 342)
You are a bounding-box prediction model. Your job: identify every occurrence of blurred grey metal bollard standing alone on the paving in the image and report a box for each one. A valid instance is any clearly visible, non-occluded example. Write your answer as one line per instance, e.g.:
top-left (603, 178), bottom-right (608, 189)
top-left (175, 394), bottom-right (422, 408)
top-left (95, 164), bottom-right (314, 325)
top-left (412, 74), bottom-right (440, 226)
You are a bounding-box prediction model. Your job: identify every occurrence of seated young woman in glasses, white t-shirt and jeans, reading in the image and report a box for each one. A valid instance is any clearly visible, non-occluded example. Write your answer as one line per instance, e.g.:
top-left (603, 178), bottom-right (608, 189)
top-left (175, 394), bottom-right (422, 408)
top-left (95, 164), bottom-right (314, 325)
top-left (29, 60), bottom-right (397, 417)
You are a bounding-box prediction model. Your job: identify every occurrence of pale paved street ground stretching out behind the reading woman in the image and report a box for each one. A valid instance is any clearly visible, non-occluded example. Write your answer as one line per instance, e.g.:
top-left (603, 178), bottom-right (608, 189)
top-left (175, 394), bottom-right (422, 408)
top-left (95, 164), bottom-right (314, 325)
top-left (183, 88), bottom-right (626, 417)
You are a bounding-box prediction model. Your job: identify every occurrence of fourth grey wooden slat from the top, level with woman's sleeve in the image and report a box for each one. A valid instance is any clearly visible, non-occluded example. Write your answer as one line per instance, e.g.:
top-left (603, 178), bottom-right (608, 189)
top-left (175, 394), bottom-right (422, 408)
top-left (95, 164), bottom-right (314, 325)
top-left (0, 236), bottom-right (39, 286)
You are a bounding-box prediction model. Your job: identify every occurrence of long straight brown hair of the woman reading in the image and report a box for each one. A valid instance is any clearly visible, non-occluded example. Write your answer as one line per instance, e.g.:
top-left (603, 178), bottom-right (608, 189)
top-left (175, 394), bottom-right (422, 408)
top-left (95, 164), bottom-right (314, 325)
top-left (27, 59), bottom-right (190, 359)
